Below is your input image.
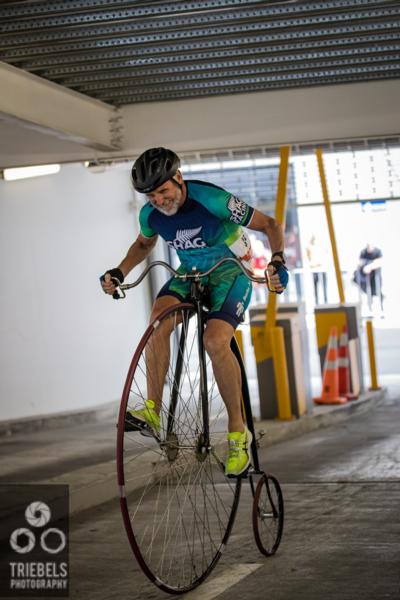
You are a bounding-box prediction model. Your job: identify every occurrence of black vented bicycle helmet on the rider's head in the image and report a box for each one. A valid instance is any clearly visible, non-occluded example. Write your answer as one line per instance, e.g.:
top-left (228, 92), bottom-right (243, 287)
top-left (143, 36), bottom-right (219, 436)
top-left (132, 148), bottom-right (181, 194)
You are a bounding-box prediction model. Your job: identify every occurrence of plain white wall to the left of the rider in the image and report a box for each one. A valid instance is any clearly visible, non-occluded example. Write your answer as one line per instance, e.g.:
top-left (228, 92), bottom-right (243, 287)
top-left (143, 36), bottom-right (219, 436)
top-left (0, 165), bottom-right (147, 420)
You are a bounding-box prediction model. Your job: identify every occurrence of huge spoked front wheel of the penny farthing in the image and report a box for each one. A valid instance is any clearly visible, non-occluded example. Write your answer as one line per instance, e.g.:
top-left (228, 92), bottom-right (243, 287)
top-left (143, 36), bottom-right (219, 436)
top-left (117, 303), bottom-right (241, 594)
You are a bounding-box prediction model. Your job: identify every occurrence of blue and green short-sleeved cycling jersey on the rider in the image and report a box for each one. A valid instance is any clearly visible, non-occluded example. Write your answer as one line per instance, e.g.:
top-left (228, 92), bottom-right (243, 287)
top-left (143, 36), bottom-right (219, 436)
top-left (139, 180), bottom-right (254, 271)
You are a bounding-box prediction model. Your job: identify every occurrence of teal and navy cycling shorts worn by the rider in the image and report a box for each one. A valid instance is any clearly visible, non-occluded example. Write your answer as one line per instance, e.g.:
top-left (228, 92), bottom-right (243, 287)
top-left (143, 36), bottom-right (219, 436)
top-left (157, 265), bottom-right (252, 329)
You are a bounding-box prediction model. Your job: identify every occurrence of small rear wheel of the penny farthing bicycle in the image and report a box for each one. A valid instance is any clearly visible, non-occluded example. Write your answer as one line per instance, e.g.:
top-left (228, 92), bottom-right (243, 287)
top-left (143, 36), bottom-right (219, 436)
top-left (253, 473), bottom-right (284, 556)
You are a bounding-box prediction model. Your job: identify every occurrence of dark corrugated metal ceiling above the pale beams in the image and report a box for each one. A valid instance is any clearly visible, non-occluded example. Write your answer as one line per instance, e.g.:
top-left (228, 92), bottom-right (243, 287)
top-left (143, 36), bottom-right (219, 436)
top-left (0, 0), bottom-right (400, 106)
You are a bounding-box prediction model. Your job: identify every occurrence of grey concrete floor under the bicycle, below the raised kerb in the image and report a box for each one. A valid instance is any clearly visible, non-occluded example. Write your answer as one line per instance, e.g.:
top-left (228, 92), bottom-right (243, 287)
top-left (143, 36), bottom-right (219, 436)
top-left (70, 396), bottom-right (400, 600)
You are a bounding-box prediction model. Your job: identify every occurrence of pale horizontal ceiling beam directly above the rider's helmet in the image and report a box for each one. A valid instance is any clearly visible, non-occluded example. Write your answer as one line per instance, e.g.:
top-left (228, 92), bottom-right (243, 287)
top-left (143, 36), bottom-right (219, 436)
top-left (121, 80), bottom-right (400, 157)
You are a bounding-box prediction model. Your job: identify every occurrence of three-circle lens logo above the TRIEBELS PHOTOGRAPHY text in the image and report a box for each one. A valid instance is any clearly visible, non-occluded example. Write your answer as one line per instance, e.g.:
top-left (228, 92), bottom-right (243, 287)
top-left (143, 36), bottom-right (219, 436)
top-left (10, 502), bottom-right (67, 554)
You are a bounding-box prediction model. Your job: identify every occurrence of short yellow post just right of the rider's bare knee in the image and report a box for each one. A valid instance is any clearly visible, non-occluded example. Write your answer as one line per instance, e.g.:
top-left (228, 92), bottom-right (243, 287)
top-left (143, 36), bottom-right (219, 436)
top-left (270, 327), bottom-right (293, 421)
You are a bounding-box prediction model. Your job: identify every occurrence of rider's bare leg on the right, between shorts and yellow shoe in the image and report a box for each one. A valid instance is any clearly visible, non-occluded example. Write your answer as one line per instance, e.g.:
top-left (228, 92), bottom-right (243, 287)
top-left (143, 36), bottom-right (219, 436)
top-left (204, 319), bottom-right (244, 432)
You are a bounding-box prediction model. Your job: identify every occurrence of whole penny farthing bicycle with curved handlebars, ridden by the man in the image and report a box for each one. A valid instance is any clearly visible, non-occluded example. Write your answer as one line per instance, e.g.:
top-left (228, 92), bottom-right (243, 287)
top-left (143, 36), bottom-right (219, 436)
top-left (114, 258), bottom-right (283, 594)
